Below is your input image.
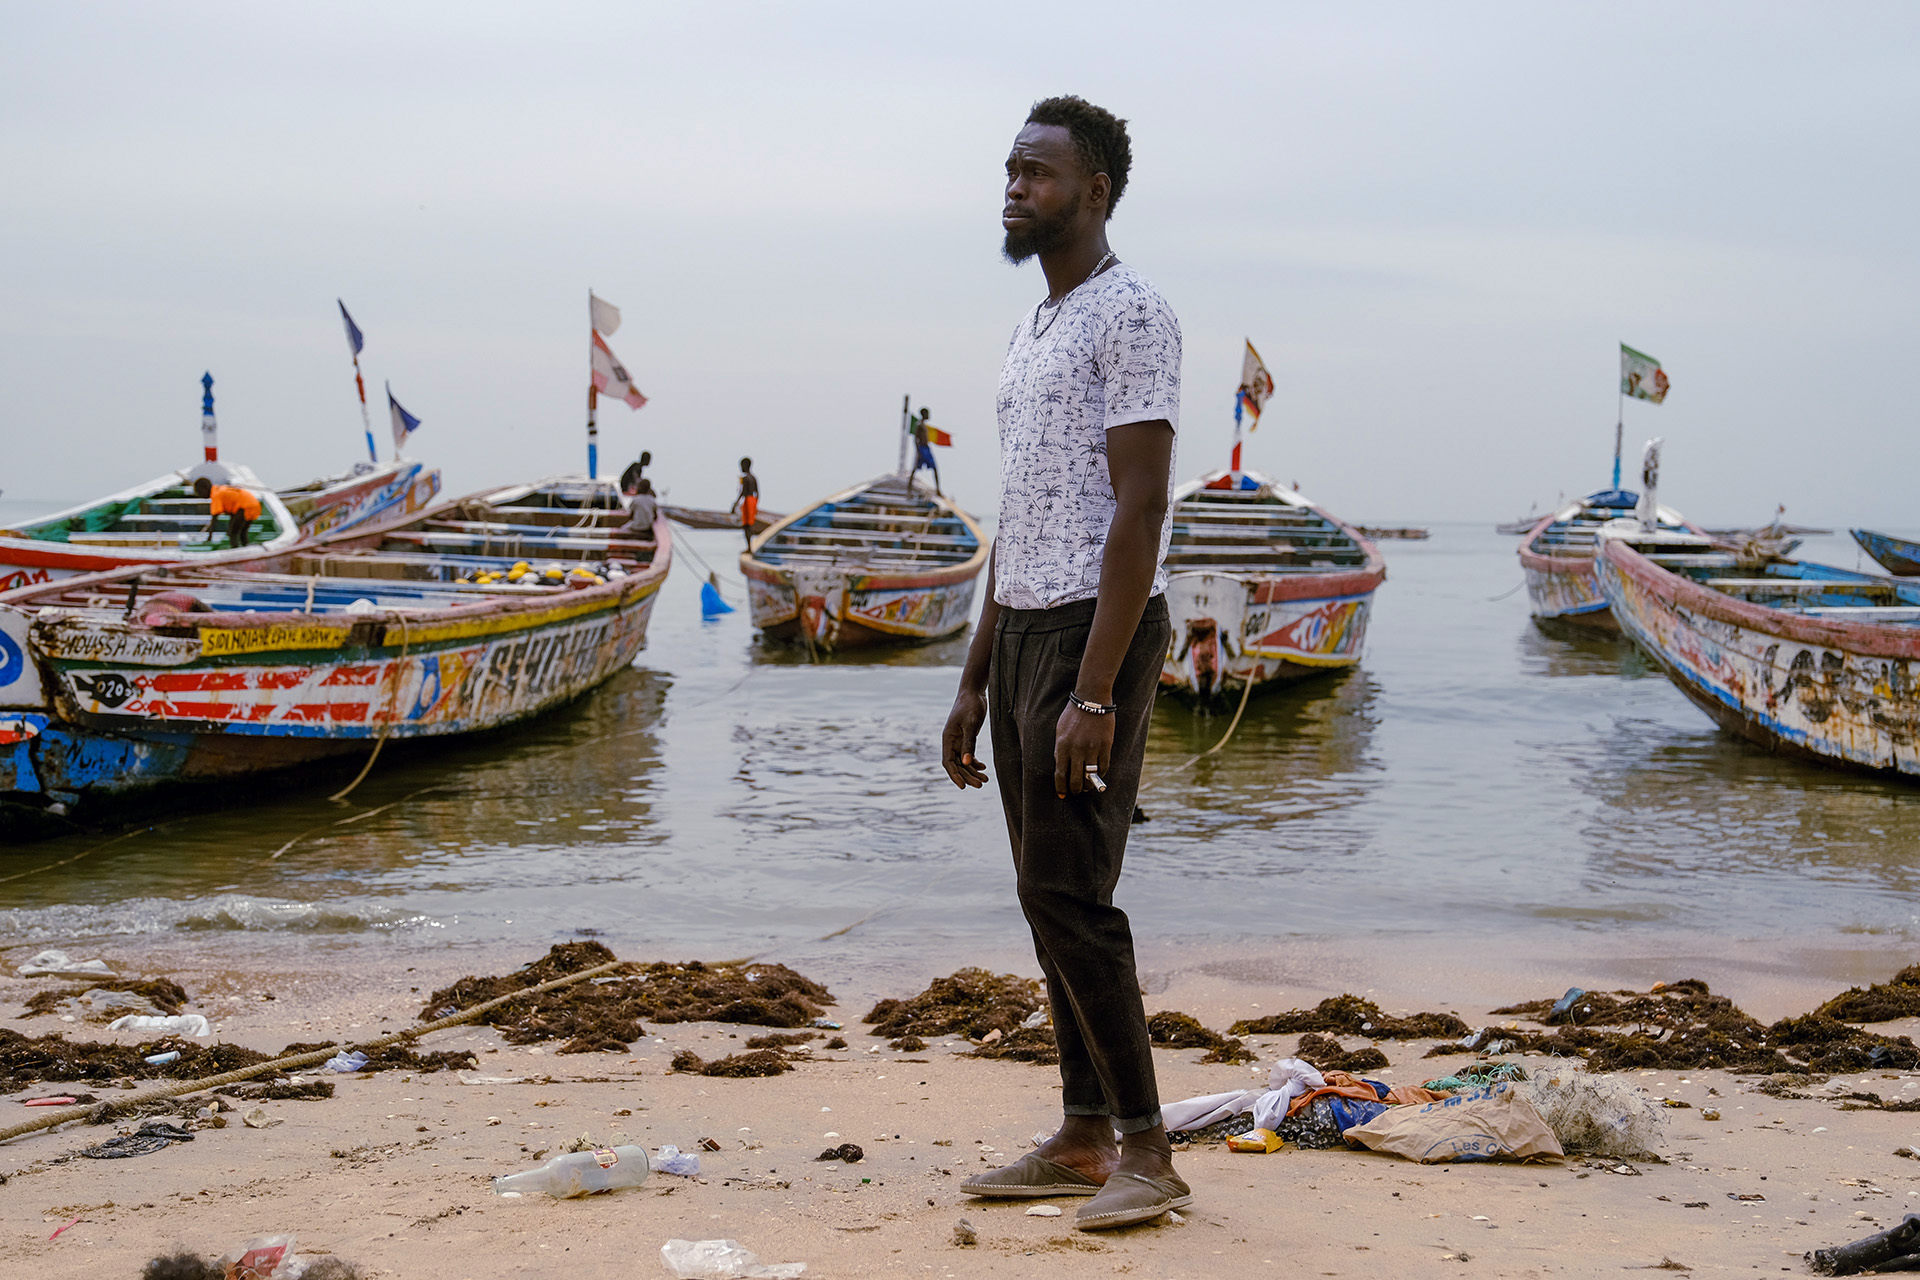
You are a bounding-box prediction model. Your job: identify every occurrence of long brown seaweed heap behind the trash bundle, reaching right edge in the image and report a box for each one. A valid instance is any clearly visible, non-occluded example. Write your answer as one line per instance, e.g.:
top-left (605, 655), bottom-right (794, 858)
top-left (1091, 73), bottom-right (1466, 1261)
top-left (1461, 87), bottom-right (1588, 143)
top-left (1451, 971), bottom-right (1920, 1075)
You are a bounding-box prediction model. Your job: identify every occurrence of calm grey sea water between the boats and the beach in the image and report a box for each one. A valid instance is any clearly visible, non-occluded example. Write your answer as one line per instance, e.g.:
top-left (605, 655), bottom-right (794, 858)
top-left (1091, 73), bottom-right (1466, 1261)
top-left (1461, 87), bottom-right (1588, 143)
top-left (0, 524), bottom-right (1920, 967)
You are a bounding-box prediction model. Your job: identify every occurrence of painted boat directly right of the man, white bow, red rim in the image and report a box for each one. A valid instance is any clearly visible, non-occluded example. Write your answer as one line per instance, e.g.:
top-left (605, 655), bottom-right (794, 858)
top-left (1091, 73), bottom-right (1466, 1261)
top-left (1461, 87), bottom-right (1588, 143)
top-left (1160, 470), bottom-right (1386, 704)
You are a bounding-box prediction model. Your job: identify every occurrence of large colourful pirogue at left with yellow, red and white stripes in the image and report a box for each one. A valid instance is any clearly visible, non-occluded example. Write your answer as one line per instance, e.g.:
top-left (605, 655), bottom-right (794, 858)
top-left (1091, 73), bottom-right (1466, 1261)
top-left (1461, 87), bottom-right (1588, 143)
top-left (0, 478), bottom-right (672, 825)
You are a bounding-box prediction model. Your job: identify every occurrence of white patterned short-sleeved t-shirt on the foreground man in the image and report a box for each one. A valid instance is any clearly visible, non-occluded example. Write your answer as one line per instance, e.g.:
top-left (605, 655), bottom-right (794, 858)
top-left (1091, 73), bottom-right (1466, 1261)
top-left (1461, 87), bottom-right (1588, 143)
top-left (993, 265), bottom-right (1181, 608)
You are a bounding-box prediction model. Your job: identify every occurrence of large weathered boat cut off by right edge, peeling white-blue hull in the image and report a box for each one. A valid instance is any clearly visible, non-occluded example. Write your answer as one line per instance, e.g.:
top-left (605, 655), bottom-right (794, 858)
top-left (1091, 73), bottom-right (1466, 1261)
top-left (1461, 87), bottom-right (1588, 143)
top-left (1596, 532), bottom-right (1920, 777)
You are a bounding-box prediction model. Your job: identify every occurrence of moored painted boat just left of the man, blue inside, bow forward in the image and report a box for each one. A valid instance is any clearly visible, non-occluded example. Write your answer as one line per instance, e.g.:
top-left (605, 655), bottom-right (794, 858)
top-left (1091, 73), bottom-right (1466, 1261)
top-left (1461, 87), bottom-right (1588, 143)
top-left (739, 474), bottom-right (987, 652)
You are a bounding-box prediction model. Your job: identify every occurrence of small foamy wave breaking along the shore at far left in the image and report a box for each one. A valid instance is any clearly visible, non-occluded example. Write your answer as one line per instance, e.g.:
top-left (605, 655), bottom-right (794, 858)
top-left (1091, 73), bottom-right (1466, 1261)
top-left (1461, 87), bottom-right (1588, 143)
top-left (0, 894), bottom-right (440, 942)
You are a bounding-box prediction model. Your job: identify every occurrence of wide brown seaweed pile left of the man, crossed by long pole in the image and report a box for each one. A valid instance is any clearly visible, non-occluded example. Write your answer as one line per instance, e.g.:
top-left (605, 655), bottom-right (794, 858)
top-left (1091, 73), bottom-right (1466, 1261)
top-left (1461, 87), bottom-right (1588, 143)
top-left (420, 942), bottom-right (833, 1054)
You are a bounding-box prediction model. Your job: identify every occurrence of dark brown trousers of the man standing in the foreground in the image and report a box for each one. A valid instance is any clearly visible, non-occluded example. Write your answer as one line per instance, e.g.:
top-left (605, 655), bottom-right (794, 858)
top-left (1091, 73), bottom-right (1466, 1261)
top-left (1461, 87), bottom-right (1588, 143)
top-left (989, 595), bottom-right (1171, 1134)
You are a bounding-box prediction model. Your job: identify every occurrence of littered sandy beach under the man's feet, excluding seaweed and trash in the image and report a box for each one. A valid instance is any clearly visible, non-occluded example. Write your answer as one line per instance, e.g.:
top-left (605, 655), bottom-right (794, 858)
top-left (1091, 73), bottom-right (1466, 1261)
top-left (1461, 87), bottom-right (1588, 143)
top-left (0, 938), bottom-right (1920, 1280)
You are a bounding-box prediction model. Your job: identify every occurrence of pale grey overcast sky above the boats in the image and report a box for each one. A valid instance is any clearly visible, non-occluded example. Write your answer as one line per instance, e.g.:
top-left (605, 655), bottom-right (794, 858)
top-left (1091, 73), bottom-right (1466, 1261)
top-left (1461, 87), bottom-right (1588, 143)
top-left (0, 0), bottom-right (1920, 524)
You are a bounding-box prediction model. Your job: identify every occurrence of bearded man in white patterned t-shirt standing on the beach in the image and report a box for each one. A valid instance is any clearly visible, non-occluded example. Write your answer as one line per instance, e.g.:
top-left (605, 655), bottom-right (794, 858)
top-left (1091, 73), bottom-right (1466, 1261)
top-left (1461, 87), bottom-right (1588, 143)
top-left (941, 98), bottom-right (1192, 1230)
